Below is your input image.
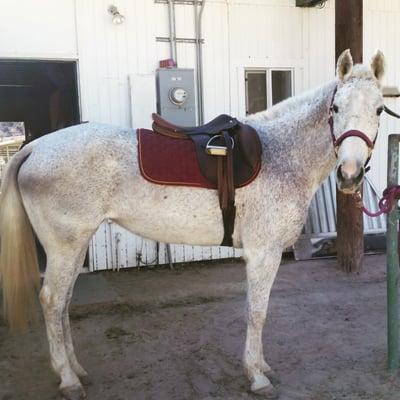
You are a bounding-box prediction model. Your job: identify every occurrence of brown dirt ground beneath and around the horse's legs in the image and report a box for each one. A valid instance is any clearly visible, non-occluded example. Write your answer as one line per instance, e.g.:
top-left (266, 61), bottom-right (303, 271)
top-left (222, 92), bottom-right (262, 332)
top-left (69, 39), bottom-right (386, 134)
top-left (0, 255), bottom-right (400, 400)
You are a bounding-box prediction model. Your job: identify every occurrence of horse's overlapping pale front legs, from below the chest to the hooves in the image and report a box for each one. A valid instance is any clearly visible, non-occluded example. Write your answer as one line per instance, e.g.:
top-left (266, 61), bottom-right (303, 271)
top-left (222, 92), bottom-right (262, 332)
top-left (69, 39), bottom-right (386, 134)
top-left (244, 248), bottom-right (282, 398)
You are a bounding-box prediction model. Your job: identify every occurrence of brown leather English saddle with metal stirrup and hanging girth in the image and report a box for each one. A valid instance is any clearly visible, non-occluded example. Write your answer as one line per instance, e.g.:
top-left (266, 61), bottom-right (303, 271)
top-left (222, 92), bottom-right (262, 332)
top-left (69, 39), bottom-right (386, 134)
top-left (152, 114), bottom-right (261, 246)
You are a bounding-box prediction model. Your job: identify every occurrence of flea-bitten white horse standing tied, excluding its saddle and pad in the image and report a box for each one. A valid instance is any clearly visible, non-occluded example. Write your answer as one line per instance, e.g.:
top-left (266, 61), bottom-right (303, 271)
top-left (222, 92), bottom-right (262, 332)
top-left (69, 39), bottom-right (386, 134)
top-left (0, 50), bottom-right (384, 400)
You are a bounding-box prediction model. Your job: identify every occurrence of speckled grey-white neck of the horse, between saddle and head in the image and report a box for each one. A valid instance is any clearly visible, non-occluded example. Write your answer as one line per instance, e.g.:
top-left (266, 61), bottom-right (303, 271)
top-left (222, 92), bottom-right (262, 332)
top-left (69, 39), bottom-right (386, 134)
top-left (245, 81), bottom-right (336, 192)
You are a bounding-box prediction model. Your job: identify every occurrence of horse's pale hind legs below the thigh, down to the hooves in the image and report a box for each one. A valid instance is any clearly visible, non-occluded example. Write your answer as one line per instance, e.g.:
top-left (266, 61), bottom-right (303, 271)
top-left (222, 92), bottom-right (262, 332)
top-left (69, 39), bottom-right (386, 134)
top-left (40, 241), bottom-right (87, 400)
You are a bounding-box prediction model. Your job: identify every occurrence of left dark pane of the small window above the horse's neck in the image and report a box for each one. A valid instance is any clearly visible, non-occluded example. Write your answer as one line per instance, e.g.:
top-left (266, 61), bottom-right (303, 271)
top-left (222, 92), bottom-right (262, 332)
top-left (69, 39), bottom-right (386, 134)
top-left (246, 71), bottom-right (267, 114)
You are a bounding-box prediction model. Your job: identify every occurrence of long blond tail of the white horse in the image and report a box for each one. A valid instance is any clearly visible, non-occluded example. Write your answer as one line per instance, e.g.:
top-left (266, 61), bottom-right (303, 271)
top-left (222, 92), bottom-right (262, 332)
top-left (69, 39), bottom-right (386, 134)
top-left (0, 144), bottom-right (40, 330)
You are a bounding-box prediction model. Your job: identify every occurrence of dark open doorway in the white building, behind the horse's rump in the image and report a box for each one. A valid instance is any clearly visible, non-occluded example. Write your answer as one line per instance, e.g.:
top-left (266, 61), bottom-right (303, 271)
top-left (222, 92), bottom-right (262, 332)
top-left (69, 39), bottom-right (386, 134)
top-left (0, 60), bottom-right (80, 270)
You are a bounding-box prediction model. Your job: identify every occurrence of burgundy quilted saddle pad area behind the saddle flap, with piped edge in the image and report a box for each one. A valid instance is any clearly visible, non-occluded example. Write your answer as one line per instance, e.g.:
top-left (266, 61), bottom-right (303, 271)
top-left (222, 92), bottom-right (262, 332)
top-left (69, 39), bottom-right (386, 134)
top-left (137, 129), bottom-right (217, 189)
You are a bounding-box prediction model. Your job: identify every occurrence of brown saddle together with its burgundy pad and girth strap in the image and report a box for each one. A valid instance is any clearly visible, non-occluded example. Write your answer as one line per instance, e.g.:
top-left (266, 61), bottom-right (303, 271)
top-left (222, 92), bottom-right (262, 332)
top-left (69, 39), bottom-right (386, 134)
top-left (137, 114), bottom-right (261, 246)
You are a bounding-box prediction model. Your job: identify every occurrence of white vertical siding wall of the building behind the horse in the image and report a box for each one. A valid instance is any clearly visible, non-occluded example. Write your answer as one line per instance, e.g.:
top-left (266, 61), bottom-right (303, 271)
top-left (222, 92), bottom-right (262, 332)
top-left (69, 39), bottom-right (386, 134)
top-left (0, 0), bottom-right (400, 269)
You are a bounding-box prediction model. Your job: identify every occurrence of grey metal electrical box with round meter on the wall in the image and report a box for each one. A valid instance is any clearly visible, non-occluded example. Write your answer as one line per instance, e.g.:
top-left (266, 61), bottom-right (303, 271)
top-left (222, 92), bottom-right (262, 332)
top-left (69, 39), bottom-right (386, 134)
top-left (156, 68), bottom-right (196, 126)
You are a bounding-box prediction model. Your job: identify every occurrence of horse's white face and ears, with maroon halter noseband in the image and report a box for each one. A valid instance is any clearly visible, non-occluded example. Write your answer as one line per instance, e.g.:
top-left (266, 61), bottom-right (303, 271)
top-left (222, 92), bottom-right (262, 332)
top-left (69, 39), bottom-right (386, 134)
top-left (330, 50), bottom-right (385, 193)
